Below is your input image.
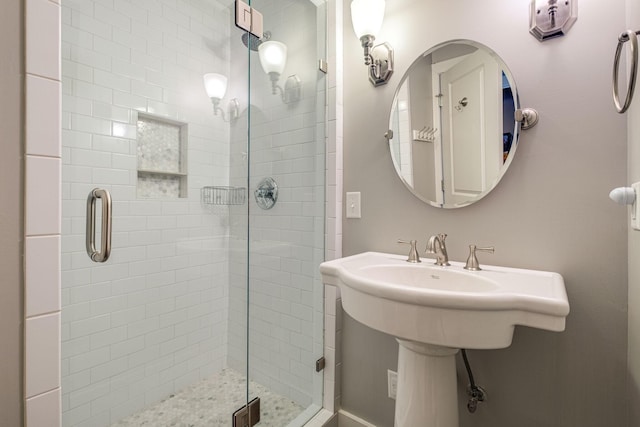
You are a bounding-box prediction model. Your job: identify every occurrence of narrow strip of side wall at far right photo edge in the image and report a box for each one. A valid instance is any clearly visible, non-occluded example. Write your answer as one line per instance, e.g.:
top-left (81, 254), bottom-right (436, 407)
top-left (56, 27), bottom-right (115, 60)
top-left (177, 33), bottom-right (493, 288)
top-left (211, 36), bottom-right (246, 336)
top-left (626, 0), bottom-right (640, 426)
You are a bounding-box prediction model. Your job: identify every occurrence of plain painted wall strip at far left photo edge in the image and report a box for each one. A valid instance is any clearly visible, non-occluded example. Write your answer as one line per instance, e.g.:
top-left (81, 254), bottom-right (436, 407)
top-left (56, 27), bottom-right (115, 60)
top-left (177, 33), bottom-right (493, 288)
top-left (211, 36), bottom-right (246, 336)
top-left (0, 0), bottom-right (24, 426)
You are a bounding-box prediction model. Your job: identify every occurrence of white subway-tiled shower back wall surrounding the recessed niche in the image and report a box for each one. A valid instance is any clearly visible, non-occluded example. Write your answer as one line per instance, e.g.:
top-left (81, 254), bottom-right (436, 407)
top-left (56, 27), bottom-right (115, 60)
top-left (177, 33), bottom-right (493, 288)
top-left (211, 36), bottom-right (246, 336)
top-left (62, 0), bottom-right (231, 426)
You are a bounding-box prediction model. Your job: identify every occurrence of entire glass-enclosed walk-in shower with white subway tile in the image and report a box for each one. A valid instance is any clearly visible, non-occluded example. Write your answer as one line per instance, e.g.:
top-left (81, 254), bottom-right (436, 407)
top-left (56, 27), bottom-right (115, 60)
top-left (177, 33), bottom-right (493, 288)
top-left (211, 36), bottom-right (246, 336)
top-left (62, 0), bottom-right (326, 427)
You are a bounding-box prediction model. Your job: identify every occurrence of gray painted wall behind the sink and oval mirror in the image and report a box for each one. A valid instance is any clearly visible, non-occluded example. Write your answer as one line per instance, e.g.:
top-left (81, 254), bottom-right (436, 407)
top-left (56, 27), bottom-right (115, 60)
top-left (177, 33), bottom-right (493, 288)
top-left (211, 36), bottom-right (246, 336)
top-left (342, 0), bottom-right (628, 427)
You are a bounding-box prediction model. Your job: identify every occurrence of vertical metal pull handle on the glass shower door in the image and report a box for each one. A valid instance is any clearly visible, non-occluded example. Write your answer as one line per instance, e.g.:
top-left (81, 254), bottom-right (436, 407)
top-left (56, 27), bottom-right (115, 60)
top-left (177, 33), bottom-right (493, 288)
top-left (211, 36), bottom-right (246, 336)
top-left (86, 188), bottom-right (111, 262)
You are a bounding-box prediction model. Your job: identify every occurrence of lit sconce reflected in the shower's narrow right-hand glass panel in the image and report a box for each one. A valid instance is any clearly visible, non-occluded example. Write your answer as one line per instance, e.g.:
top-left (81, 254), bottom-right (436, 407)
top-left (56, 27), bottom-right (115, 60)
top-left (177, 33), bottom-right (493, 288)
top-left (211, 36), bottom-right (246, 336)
top-left (258, 40), bottom-right (302, 104)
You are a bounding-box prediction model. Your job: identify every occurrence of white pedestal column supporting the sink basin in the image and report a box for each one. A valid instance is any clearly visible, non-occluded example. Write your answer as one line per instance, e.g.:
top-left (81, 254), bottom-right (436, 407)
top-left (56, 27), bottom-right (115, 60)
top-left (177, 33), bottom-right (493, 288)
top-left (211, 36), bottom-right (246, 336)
top-left (395, 339), bottom-right (458, 427)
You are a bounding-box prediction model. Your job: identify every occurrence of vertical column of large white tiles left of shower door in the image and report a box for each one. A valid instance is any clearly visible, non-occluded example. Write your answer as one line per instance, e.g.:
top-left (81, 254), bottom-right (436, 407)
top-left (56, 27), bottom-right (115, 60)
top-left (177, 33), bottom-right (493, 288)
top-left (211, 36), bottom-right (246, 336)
top-left (24, 0), bottom-right (62, 427)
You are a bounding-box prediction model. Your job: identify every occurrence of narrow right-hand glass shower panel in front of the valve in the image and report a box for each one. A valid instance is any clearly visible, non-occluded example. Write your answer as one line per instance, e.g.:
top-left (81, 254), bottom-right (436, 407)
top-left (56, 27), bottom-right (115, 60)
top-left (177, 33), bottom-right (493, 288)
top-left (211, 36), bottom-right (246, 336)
top-left (242, 0), bottom-right (326, 426)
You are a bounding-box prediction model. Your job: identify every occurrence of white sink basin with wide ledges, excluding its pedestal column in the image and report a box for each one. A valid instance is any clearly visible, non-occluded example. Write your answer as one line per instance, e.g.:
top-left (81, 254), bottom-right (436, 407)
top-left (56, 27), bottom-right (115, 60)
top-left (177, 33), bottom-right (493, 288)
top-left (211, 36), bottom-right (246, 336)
top-left (320, 252), bottom-right (569, 349)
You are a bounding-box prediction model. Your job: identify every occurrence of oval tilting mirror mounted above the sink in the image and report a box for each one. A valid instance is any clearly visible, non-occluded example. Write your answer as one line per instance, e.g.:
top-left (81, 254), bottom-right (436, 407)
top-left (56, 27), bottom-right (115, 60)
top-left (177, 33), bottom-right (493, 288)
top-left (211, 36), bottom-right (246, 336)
top-left (387, 40), bottom-right (520, 208)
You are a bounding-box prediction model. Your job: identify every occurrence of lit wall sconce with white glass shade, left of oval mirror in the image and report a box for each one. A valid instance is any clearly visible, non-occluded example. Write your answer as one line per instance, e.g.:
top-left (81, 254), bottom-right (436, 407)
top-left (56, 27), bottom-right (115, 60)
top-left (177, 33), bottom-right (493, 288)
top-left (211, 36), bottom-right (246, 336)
top-left (351, 0), bottom-right (393, 86)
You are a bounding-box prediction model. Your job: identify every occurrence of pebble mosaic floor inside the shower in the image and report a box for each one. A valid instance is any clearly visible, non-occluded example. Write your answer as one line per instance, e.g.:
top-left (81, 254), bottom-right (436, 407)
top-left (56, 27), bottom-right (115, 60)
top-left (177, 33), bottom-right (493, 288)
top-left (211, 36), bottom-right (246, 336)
top-left (112, 369), bottom-right (304, 427)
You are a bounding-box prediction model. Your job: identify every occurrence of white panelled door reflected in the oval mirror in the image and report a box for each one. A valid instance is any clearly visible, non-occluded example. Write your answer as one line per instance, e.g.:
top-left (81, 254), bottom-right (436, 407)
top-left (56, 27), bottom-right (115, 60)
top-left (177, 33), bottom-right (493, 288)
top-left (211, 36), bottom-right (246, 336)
top-left (434, 49), bottom-right (504, 206)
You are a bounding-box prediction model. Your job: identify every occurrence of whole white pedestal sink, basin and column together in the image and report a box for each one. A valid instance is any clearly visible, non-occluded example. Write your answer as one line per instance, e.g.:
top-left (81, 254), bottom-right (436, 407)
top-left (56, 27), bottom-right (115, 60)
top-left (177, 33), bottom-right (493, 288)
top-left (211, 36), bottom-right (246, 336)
top-left (320, 252), bottom-right (569, 427)
